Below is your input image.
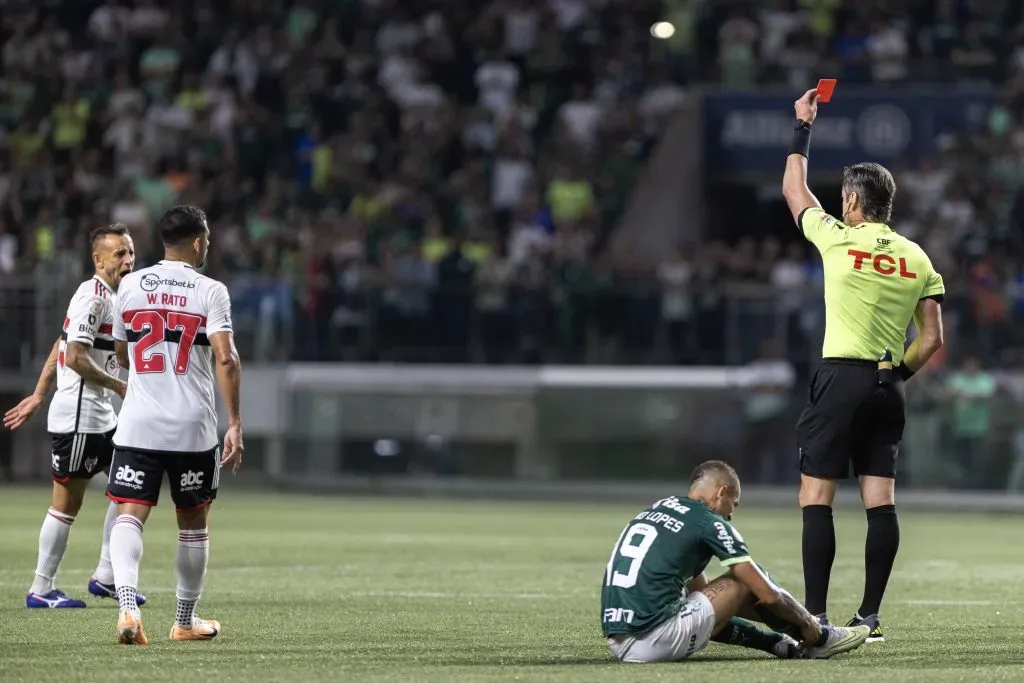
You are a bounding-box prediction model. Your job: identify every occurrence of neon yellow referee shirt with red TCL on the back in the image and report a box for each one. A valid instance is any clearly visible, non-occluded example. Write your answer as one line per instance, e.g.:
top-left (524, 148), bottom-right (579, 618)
top-left (800, 207), bottom-right (945, 365)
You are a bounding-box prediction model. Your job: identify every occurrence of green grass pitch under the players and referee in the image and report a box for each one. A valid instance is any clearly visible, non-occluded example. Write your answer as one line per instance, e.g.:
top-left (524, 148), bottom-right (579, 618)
top-left (0, 487), bottom-right (1024, 683)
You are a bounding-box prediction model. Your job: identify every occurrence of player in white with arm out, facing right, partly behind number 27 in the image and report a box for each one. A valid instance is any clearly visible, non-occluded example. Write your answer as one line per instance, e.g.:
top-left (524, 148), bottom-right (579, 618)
top-left (4, 223), bottom-right (145, 608)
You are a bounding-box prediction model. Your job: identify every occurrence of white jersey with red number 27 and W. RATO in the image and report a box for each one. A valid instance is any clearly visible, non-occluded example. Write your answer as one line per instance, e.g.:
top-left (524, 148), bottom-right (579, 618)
top-left (114, 261), bottom-right (231, 453)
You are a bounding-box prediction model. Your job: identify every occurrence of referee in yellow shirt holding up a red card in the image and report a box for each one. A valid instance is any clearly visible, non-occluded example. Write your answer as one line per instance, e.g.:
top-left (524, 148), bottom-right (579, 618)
top-left (782, 90), bottom-right (945, 642)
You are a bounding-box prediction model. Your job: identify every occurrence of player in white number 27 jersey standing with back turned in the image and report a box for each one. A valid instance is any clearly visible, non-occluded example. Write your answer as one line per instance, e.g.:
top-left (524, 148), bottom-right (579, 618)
top-left (106, 206), bottom-right (243, 645)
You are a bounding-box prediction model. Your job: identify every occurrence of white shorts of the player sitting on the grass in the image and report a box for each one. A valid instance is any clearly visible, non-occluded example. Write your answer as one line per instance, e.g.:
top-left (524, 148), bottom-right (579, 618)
top-left (608, 592), bottom-right (715, 664)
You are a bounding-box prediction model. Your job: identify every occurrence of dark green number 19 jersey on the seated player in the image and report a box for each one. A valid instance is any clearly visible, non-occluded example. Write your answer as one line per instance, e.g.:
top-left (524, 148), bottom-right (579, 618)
top-left (601, 496), bottom-right (751, 636)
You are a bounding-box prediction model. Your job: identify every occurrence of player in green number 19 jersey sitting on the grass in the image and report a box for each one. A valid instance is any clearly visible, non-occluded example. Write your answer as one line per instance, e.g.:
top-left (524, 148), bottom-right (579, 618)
top-left (601, 460), bottom-right (870, 663)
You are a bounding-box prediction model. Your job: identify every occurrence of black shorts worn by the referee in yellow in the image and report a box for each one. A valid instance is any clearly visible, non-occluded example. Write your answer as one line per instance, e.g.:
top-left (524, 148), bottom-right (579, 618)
top-left (797, 358), bottom-right (906, 479)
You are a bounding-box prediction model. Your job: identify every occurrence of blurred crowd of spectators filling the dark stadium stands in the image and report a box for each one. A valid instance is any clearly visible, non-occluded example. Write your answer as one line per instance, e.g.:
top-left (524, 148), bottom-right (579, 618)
top-left (0, 0), bottom-right (1024, 373)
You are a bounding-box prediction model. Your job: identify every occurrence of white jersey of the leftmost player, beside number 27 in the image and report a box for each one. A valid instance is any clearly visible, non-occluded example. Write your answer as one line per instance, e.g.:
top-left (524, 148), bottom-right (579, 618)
top-left (46, 275), bottom-right (121, 434)
